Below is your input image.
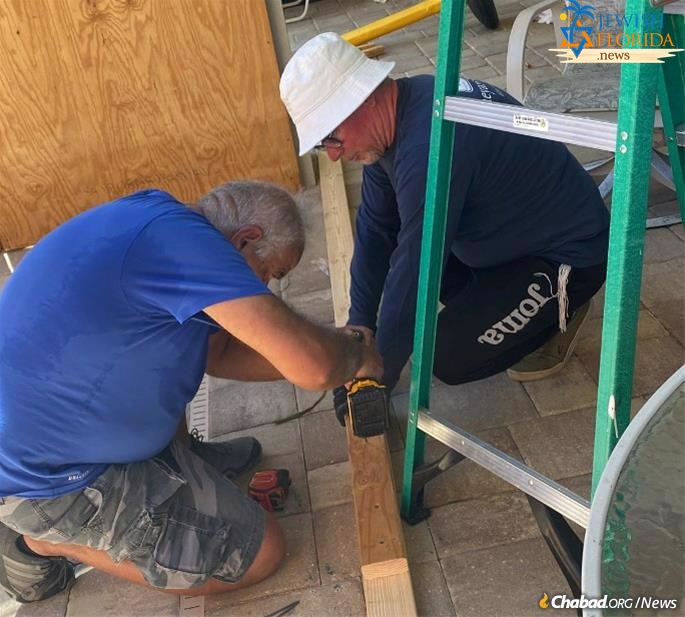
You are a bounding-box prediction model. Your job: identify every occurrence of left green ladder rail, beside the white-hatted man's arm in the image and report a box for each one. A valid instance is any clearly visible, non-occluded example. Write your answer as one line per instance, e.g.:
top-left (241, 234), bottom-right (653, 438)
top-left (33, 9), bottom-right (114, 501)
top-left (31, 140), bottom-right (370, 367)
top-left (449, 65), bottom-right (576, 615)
top-left (401, 0), bottom-right (466, 519)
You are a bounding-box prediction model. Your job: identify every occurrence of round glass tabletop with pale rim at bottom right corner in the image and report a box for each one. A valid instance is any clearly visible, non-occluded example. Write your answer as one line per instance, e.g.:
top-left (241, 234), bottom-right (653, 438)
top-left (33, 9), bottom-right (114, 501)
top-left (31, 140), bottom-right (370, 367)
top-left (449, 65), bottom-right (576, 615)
top-left (583, 369), bottom-right (685, 615)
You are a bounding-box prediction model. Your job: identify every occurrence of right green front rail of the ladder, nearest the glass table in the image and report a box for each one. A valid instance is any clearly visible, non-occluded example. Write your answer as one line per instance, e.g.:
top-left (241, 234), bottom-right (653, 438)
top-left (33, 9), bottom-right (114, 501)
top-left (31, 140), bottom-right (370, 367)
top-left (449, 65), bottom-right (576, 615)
top-left (592, 0), bottom-right (661, 495)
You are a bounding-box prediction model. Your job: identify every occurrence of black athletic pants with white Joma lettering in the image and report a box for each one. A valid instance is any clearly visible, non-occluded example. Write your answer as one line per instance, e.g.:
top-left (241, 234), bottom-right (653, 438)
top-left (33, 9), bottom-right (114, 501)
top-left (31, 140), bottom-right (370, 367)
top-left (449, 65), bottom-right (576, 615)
top-left (434, 257), bottom-right (606, 385)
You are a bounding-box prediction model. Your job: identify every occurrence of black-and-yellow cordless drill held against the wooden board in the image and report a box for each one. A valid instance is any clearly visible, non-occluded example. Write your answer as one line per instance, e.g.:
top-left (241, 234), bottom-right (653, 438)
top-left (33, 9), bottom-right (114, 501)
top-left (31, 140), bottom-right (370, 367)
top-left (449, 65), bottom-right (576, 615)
top-left (333, 332), bottom-right (390, 437)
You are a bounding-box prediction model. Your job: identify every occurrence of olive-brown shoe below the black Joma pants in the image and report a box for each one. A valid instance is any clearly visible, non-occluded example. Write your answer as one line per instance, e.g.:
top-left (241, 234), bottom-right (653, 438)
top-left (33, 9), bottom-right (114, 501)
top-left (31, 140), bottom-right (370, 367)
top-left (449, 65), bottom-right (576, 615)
top-left (507, 300), bottom-right (592, 381)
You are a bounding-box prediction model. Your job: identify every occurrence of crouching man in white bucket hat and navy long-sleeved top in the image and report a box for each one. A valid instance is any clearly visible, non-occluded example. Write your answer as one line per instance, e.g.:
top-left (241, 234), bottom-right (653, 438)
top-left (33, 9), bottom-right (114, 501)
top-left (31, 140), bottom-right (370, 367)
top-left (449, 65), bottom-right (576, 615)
top-left (281, 33), bottom-right (608, 400)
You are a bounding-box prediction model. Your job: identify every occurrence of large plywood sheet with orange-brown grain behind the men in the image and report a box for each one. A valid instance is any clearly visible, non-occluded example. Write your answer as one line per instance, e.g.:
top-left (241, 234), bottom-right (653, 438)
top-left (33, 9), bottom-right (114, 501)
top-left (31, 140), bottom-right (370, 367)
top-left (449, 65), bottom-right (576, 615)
top-left (0, 0), bottom-right (298, 249)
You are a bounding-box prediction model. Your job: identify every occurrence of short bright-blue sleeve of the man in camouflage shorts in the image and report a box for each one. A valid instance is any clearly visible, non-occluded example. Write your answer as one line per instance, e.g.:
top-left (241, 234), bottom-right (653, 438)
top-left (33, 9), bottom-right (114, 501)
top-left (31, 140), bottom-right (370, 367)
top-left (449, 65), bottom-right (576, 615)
top-left (121, 208), bottom-right (270, 323)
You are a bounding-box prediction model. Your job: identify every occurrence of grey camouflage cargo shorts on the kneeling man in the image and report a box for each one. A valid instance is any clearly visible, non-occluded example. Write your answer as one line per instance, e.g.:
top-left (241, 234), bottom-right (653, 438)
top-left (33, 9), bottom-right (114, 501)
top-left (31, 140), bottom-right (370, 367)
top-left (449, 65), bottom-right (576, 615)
top-left (0, 441), bottom-right (265, 589)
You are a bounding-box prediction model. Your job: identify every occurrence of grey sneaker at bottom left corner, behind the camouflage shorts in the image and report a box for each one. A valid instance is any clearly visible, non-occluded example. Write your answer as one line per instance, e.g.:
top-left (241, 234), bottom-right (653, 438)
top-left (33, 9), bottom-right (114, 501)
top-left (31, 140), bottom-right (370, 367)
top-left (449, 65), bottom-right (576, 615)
top-left (0, 523), bottom-right (74, 602)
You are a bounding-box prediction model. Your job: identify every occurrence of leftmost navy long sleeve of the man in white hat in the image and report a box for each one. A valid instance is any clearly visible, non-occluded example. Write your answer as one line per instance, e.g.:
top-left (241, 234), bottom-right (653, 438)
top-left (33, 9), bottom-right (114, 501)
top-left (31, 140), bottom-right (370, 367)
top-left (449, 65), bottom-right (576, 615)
top-left (348, 164), bottom-right (400, 330)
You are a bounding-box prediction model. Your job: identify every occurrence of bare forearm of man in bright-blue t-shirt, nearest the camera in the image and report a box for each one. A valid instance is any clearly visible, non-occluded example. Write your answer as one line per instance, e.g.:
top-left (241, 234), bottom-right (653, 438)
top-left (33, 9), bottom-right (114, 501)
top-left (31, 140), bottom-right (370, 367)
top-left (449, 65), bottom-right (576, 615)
top-left (204, 295), bottom-right (383, 390)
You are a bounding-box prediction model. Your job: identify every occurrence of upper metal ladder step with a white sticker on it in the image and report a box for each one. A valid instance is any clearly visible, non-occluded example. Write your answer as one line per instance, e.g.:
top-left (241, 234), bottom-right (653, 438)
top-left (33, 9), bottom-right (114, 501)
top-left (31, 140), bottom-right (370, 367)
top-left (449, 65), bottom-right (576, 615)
top-left (443, 96), bottom-right (616, 152)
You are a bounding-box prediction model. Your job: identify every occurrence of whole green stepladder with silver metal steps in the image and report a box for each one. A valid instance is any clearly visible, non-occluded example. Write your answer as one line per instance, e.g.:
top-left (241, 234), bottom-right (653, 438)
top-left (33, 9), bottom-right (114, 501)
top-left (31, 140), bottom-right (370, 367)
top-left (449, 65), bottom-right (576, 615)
top-left (402, 0), bottom-right (685, 594)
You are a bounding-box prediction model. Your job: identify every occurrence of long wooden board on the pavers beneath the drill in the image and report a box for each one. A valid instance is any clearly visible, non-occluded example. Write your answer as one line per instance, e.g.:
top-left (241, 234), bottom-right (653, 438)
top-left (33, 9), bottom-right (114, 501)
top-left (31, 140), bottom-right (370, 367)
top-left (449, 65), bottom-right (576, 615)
top-left (319, 154), bottom-right (416, 617)
